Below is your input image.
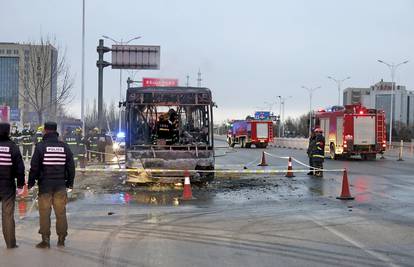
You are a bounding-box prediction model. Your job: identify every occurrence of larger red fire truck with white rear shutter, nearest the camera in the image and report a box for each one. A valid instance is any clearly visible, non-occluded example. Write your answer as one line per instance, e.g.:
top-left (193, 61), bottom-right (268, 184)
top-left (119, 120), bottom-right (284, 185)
top-left (315, 105), bottom-right (386, 160)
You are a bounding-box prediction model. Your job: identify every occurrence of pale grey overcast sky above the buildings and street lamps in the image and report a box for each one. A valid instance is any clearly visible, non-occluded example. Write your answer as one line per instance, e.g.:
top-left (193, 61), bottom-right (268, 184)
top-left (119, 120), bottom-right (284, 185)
top-left (0, 0), bottom-right (414, 120)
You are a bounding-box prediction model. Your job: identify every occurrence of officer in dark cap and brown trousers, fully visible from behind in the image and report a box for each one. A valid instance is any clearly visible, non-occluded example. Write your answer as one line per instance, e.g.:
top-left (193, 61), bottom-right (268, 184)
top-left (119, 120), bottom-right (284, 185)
top-left (28, 122), bottom-right (75, 248)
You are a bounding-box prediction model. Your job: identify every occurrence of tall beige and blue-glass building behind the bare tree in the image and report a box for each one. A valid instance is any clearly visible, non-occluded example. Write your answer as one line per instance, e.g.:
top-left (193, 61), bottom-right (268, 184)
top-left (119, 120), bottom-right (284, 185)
top-left (0, 43), bottom-right (58, 124)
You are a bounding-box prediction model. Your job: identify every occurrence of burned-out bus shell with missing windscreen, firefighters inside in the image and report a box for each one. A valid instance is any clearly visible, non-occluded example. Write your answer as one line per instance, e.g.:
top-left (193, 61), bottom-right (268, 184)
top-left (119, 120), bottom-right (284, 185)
top-left (125, 87), bottom-right (214, 183)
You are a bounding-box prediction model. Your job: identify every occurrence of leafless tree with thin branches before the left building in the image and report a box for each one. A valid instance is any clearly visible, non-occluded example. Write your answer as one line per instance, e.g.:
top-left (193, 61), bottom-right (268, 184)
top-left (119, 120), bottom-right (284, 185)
top-left (19, 37), bottom-right (74, 124)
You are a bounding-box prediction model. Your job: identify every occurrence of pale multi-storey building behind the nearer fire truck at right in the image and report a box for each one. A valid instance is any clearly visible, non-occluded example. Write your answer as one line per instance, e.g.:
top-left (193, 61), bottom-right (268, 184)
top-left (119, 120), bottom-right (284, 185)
top-left (343, 80), bottom-right (414, 127)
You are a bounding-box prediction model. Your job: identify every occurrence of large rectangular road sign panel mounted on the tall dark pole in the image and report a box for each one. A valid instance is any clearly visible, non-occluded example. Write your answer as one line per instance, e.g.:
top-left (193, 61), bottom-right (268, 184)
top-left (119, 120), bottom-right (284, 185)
top-left (111, 45), bottom-right (161, 70)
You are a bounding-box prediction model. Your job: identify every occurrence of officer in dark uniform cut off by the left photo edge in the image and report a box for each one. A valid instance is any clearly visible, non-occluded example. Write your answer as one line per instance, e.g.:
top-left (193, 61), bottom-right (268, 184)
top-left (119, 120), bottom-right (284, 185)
top-left (0, 122), bottom-right (24, 248)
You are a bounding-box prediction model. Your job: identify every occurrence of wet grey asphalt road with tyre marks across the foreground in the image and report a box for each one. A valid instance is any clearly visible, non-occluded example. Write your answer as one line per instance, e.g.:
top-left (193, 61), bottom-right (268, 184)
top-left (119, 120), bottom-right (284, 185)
top-left (0, 139), bottom-right (414, 266)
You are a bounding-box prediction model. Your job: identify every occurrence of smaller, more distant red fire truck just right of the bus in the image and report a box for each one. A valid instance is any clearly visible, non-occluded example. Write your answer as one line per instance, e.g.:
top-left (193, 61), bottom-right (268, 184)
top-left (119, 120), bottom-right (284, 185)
top-left (227, 120), bottom-right (273, 148)
